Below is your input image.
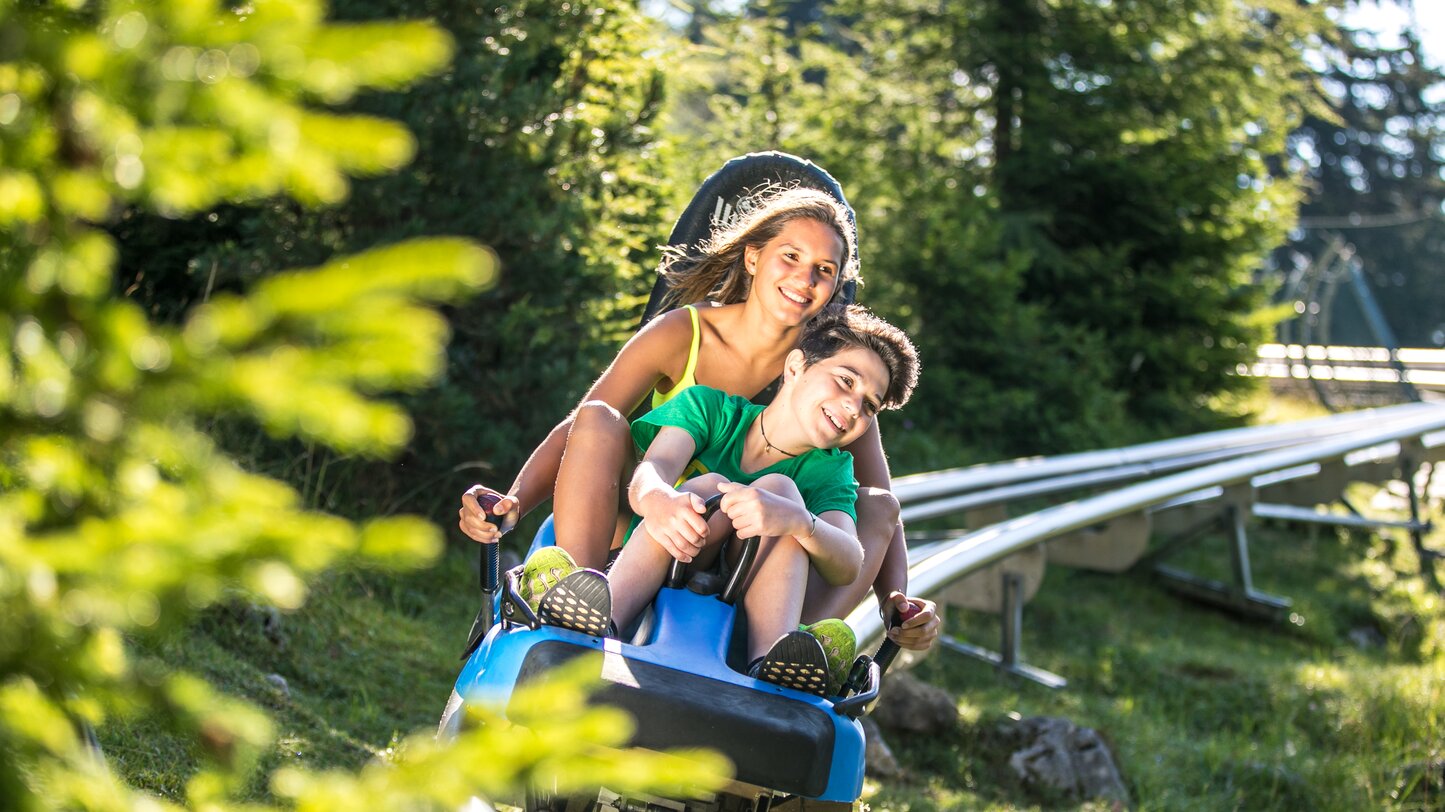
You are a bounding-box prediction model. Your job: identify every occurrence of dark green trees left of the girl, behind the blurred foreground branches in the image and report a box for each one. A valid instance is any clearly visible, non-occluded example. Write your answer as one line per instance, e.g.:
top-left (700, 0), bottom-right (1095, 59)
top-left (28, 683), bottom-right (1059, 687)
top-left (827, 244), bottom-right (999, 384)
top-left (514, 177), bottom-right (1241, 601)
top-left (114, 0), bottom-right (676, 516)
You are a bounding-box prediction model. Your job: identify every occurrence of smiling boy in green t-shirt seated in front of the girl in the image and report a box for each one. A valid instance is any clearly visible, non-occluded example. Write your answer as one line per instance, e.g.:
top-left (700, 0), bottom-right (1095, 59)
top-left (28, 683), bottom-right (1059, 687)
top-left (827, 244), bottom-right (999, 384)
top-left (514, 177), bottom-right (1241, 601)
top-left (523, 305), bottom-right (918, 694)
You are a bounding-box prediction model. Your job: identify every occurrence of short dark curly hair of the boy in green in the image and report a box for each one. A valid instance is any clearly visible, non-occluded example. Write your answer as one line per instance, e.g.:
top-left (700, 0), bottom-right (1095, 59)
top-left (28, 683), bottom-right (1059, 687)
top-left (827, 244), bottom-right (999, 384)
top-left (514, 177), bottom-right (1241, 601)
top-left (798, 305), bottom-right (919, 409)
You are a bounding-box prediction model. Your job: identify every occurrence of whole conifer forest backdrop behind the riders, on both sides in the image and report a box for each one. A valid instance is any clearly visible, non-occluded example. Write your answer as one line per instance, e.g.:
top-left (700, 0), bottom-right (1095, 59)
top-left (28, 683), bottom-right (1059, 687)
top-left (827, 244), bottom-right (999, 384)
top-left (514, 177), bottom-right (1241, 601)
top-left (113, 0), bottom-right (1445, 516)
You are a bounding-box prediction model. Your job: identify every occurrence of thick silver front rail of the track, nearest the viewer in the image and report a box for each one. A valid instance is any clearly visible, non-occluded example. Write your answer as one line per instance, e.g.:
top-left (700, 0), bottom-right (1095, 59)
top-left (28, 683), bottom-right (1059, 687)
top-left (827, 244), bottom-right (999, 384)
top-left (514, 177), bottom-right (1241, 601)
top-left (847, 403), bottom-right (1445, 647)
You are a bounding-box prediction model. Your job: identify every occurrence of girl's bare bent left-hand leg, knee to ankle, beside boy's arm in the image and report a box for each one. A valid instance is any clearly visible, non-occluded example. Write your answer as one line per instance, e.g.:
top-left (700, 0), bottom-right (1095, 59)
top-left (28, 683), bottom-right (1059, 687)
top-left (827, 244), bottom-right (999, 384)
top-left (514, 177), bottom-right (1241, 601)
top-left (552, 400), bottom-right (636, 569)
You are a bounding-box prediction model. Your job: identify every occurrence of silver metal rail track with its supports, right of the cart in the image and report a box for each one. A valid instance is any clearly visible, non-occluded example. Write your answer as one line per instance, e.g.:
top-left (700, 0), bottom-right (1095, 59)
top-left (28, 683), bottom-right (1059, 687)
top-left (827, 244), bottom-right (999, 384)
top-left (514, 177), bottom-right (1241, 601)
top-left (847, 403), bottom-right (1445, 686)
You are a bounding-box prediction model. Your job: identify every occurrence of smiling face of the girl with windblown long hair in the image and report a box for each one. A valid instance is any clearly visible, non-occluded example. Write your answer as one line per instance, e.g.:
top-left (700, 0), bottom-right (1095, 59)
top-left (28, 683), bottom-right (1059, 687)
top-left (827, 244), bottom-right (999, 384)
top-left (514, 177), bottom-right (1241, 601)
top-left (743, 218), bottom-right (842, 325)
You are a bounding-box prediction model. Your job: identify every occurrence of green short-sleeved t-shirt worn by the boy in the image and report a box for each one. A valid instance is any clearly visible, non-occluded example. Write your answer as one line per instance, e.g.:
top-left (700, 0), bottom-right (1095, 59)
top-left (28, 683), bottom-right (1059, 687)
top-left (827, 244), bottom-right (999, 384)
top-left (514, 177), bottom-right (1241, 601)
top-left (631, 386), bottom-right (858, 522)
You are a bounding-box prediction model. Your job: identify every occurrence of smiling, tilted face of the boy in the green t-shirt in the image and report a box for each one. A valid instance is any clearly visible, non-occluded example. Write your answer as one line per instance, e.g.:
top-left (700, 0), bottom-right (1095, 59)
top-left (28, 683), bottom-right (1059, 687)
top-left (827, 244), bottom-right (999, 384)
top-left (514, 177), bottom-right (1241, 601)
top-left (789, 347), bottom-right (889, 448)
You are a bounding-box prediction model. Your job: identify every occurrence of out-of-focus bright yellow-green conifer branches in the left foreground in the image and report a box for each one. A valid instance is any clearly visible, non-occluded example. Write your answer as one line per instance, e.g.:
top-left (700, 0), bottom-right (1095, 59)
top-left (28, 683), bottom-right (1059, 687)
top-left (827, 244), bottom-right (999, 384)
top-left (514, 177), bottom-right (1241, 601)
top-left (0, 0), bottom-right (724, 809)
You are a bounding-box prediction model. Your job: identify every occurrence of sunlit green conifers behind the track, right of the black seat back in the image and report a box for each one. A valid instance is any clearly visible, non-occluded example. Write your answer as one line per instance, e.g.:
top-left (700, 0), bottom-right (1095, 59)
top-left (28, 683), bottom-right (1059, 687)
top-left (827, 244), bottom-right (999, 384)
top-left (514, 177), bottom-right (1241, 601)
top-left (681, 0), bottom-right (1331, 452)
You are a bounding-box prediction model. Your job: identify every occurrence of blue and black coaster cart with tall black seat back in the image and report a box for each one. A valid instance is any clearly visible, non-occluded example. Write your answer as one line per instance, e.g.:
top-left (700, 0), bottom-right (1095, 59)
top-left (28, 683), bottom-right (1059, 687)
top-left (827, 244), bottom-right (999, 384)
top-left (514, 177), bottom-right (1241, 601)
top-left (439, 152), bottom-right (893, 812)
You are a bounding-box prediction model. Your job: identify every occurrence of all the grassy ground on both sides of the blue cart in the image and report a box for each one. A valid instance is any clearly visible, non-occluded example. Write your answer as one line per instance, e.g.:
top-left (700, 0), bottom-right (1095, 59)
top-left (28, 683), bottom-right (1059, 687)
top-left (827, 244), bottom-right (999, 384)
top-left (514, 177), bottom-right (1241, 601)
top-left (103, 497), bottom-right (1445, 811)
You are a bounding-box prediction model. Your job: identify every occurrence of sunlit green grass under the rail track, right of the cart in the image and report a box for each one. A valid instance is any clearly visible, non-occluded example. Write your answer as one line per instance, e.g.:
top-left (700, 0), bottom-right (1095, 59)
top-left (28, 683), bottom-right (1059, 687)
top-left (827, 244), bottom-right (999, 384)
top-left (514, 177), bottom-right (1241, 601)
top-left (868, 508), bottom-right (1445, 812)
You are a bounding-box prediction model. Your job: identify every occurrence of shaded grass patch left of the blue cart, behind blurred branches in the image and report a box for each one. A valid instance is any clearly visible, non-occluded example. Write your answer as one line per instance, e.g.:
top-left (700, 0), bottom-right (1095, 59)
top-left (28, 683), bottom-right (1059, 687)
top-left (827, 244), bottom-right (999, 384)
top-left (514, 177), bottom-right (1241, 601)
top-left (100, 549), bottom-right (477, 799)
